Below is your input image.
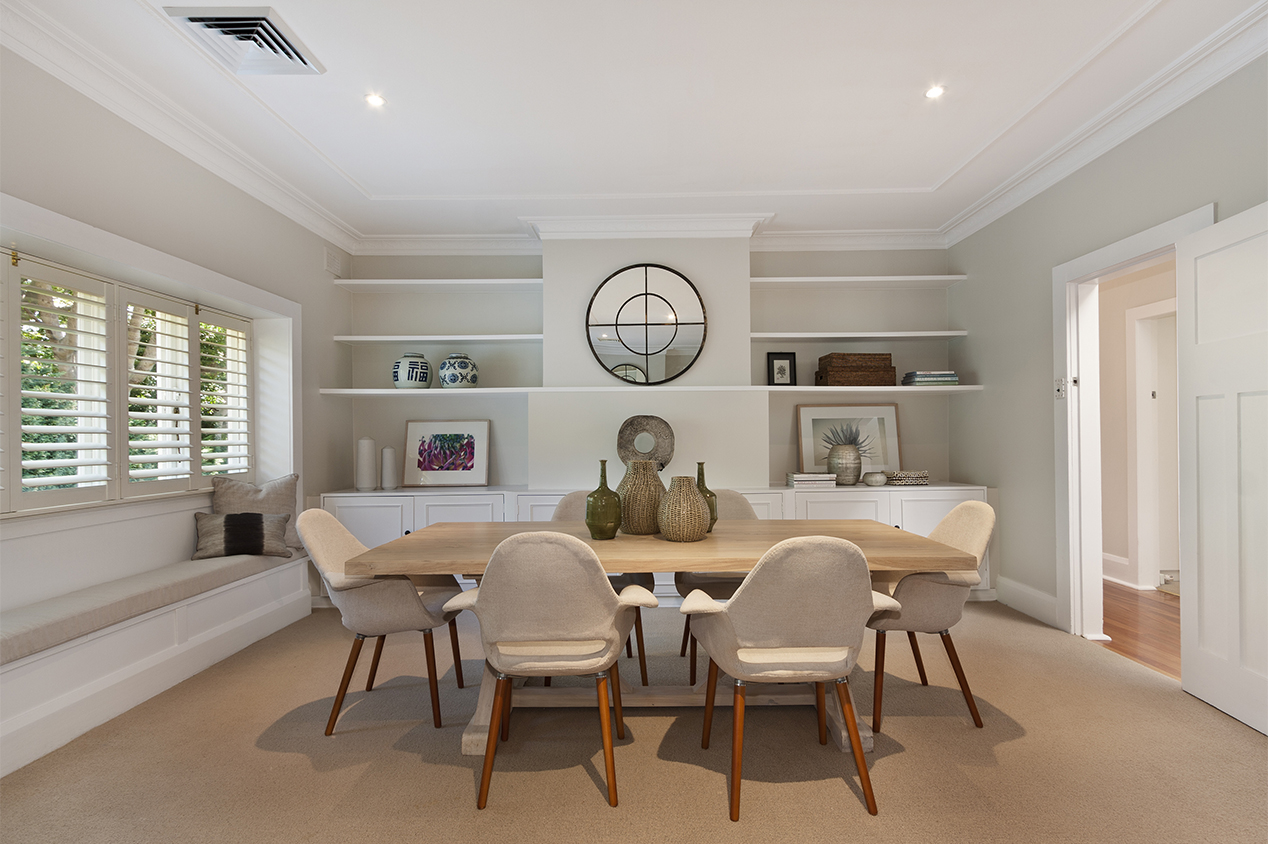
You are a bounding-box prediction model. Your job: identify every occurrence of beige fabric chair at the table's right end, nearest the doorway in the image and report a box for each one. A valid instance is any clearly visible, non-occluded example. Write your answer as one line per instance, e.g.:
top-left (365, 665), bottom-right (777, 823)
top-left (867, 501), bottom-right (995, 732)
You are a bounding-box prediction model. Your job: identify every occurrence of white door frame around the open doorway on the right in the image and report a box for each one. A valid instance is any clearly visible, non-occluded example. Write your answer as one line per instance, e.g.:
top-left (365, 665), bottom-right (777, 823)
top-left (1052, 204), bottom-right (1215, 633)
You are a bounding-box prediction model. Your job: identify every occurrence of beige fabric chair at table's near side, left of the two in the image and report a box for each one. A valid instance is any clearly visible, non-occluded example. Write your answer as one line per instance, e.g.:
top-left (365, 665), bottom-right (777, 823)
top-left (445, 531), bottom-right (657, 809)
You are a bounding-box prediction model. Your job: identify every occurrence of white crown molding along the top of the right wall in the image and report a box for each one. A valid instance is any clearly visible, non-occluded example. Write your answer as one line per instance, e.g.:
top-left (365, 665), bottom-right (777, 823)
top-left (940, 0), bottom-right (1268, 247)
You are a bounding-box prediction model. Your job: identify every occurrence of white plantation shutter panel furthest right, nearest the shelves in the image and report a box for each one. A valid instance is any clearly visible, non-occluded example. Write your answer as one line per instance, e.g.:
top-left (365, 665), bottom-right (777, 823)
top-left (198, 310), bottom-right (252, 476)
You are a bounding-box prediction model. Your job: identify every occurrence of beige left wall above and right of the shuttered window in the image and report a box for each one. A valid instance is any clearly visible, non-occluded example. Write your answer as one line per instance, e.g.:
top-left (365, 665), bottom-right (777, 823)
top-left (0, 49), bottom-right (353, 496)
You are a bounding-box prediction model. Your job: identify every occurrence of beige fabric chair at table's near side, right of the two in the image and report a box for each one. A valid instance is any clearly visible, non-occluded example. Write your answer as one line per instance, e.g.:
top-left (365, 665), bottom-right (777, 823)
top-left (681, 536), bottom-right (899, 820)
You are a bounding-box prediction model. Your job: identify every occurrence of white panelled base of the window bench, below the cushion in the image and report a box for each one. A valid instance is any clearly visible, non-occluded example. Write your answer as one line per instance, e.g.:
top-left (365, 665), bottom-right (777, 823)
top-left (0, 558), bottom-right (312, 776)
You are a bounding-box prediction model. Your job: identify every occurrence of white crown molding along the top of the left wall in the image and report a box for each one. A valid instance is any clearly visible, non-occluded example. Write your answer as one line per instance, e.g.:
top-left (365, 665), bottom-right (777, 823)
top-left (0, 0), bottom-right (360, 251)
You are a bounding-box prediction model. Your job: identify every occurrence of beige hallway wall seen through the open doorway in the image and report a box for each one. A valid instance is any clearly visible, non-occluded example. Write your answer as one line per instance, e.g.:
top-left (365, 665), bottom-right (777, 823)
top-left (1098, 261), bottom-right (1175, 558)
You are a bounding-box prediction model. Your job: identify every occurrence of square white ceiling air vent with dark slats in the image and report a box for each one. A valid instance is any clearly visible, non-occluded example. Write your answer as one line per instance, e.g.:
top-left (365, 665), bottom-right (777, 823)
top-left (164, 6), bottom-right (326, 76)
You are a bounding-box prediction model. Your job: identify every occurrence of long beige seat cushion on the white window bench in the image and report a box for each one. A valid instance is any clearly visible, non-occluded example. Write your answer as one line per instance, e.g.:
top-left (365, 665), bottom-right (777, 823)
top-left (0, 553), bottom-right (302, 665)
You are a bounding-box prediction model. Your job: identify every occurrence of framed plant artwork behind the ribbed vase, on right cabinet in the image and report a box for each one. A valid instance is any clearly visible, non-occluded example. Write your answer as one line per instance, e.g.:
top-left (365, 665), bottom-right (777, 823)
top-left (796, 404), bottom-right (902, 471)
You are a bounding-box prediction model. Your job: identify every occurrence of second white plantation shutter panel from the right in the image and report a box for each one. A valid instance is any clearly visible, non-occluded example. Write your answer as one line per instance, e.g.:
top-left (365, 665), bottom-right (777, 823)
top-left (123, 290), bottom-right (193, 496)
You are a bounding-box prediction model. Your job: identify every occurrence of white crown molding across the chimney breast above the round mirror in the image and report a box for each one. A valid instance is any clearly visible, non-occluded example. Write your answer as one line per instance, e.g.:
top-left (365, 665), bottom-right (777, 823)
top-left (520, 214), bottom-right (775, 241)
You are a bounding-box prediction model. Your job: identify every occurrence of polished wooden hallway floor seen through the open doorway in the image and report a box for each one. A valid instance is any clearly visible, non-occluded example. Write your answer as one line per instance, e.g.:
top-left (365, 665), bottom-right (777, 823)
top-left (1101, 580), bottom-right (1181, 679)
